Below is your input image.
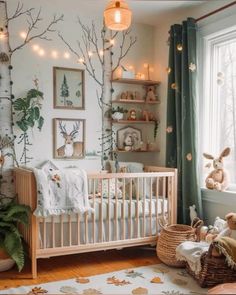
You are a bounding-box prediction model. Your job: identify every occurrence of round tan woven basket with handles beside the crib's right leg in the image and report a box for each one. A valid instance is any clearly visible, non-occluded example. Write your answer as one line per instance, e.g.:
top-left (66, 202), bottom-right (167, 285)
top-left (157, 220), bottom-right (202, 267)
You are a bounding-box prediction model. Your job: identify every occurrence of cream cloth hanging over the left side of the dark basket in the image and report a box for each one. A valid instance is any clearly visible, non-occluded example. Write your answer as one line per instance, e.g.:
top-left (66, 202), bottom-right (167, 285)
top-left (176, 241), bottom-right (209, 274)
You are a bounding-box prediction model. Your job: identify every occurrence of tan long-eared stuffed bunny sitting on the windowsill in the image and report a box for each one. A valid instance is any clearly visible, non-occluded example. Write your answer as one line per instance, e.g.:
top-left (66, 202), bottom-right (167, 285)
top-left (203, 147), bottom-right (230, 191)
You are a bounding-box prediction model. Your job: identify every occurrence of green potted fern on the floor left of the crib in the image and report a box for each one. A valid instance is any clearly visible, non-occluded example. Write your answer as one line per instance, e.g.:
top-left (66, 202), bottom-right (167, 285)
top-left (0, 201), bottom-right (30, 271)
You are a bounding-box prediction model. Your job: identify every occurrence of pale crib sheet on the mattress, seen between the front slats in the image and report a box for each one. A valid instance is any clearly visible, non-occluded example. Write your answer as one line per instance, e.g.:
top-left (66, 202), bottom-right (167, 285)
top-left (39, 199), bottom-right (168, 248)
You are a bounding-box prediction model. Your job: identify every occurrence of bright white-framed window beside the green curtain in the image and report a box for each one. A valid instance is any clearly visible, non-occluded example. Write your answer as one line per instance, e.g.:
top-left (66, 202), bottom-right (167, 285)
top-left (200, 27), bottom-right (236, 184)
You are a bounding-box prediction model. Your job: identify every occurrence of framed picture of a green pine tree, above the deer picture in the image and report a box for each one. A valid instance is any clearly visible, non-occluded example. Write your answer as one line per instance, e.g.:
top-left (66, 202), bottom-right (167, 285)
top-left (53, 67), bottom-right (85, 110)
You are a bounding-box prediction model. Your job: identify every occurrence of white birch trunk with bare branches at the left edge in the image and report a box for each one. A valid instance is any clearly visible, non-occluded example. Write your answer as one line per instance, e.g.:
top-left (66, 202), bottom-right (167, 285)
top-left (0, 0), bottom-right (63, 203)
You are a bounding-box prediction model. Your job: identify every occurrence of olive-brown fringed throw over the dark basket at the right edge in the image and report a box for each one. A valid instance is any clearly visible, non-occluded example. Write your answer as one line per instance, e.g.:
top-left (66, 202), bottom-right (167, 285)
top-left (213, 237), bottom-right (236, 269)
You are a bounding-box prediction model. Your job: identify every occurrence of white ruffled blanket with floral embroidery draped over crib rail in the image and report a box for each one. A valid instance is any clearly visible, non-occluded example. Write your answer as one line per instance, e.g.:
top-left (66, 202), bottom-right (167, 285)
top-left (34, 168), bottom-right (93, 217)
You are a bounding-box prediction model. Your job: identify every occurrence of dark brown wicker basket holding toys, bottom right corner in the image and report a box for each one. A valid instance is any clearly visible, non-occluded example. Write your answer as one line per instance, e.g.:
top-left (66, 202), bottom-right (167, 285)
top-left (186, 246), bottom-right (236, 288)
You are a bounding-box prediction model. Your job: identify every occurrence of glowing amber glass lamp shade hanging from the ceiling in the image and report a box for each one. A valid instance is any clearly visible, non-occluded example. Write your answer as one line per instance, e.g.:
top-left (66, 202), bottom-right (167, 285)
top-left (104, 0), bottom-right (132, 31)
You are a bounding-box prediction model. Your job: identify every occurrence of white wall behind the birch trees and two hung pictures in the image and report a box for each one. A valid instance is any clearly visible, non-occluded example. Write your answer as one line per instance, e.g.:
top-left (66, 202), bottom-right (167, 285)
top-left (8, 0), bottom-right (154, 170)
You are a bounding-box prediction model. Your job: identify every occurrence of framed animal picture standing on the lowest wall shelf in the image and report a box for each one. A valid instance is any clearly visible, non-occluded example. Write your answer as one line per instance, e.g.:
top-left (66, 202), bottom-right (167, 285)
top-left (117, 126), bottom-right (142, 151)
